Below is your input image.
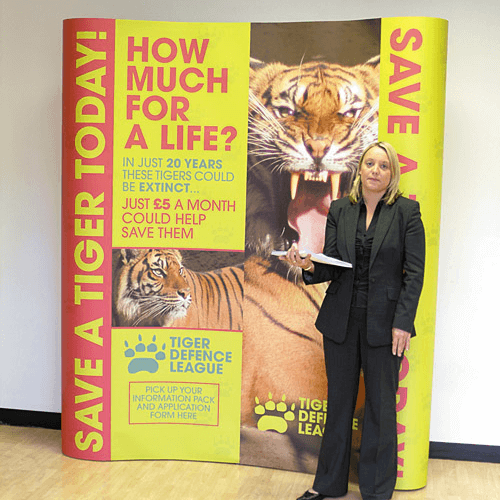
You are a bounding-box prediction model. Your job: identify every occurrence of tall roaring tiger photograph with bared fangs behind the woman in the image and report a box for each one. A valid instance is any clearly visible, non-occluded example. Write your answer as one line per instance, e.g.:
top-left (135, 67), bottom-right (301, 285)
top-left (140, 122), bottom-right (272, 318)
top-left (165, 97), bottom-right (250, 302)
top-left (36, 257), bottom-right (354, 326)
top-left (240, 20), bottom-right (380, 475)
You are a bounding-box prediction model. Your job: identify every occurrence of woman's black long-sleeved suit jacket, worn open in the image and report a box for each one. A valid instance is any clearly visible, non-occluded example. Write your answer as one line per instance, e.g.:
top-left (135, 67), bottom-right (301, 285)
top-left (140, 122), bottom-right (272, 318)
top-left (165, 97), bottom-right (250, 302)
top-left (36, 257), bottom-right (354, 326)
top-left (303, 196), bottom-right (425, 347)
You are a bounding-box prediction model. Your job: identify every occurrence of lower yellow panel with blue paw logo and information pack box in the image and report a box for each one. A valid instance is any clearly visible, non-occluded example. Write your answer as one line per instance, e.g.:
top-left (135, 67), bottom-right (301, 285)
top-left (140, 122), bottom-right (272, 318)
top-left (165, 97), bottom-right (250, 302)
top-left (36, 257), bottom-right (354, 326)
top-left (111, 328), bottom-right (242, 463)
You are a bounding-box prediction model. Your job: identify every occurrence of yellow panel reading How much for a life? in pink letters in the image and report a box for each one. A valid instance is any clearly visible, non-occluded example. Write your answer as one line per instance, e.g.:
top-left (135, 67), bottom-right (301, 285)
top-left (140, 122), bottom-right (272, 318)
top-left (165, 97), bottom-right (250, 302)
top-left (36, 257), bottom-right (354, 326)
top-left (113, 21), bottom-right (250, 250)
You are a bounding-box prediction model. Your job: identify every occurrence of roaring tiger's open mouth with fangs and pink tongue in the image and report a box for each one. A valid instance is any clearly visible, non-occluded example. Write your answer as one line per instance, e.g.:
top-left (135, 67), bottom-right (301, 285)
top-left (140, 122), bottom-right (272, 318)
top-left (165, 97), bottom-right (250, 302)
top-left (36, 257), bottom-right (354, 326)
top-left (288, 170), bottom-right (342, 253)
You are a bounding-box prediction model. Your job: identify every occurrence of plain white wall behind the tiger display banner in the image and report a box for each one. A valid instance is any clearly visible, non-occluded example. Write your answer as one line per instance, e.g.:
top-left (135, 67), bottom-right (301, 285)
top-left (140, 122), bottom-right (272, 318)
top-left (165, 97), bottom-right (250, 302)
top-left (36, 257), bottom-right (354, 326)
top-left (0, 0), bottom-right (500, 446)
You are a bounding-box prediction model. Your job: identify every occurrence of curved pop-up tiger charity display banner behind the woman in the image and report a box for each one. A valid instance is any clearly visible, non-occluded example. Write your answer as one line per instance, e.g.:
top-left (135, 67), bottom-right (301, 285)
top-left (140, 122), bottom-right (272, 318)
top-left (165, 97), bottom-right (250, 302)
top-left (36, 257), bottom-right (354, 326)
top-left (62, 18), bottom-right (447, 489)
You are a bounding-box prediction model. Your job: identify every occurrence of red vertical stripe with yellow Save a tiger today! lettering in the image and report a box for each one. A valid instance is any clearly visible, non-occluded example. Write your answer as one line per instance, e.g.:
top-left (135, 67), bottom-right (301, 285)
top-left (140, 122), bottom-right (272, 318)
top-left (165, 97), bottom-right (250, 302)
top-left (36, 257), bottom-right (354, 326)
top-left (62, 19), bottom-right (115, 460)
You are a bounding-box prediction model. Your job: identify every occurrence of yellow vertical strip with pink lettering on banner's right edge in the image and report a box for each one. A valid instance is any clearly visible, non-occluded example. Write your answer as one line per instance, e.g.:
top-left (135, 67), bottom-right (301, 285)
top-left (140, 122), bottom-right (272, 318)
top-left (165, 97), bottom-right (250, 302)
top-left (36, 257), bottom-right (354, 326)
top-left (379, 17), bottom-right (448, 490)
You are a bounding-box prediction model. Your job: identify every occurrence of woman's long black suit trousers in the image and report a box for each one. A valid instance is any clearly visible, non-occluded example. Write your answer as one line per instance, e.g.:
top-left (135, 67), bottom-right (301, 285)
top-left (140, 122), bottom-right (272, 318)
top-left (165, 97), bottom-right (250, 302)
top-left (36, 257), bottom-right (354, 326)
top-left (313, 307), bottom-right (402, 500)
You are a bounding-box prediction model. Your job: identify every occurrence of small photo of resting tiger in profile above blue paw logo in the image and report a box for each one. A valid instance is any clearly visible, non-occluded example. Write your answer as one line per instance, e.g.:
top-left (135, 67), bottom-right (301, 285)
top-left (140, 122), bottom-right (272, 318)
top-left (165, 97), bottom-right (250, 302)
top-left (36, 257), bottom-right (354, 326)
top-left (113, 248), bottom-right (244, 331)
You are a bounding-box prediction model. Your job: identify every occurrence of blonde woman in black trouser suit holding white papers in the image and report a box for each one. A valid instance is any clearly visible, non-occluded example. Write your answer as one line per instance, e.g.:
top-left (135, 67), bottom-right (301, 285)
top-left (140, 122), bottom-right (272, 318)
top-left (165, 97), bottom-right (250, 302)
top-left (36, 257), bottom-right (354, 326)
top-left (283, 142), bottom-right (425, 500)
